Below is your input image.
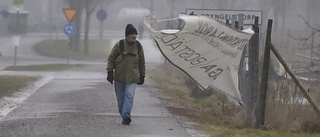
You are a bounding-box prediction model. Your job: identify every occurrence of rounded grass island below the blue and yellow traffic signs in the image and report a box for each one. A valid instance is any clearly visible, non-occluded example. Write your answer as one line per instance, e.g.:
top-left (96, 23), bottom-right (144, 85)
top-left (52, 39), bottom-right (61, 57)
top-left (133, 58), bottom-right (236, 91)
top-left (34, 39), bottom-right (110, 60)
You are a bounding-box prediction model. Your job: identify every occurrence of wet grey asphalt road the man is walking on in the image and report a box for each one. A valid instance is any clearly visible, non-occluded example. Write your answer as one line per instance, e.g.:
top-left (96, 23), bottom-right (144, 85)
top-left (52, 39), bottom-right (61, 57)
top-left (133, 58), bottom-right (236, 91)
top-left (0, 35), bottom-right (198, 137)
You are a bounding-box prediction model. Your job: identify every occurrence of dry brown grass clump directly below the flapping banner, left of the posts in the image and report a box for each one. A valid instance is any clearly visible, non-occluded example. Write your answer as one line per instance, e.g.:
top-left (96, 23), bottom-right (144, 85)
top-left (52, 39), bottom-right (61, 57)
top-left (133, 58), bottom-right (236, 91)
top-left (149, 65), bottom-right (247, 127)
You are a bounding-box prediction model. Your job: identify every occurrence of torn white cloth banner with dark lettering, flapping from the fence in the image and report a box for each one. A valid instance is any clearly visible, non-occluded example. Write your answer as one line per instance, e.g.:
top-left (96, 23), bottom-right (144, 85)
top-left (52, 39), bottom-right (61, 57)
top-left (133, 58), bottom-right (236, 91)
top-left (145, 15), bottom-right (252, 102)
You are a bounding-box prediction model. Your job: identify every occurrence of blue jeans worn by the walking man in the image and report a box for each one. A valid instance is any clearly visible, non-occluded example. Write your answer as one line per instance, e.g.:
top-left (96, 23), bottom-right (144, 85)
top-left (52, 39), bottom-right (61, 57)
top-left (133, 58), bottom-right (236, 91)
top-left (114, 81), bottom-right (137, 118)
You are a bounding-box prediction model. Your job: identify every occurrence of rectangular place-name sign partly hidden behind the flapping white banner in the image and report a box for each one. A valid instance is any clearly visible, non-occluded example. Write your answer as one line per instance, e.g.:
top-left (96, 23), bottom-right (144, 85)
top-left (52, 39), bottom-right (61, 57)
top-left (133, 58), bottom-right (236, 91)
top-left (186, 9), bottom-right (262, 25)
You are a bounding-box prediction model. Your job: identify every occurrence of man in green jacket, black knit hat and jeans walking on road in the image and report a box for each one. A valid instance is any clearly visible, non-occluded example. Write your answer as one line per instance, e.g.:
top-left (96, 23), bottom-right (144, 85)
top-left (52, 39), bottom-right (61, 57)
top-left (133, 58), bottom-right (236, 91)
top-left (107, 24), bottom-right (145, 125)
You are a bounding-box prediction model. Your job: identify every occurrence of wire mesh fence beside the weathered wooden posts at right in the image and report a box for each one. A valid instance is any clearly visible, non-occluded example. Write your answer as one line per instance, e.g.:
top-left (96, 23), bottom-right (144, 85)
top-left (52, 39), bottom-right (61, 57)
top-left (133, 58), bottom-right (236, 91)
top-left (239, 27), bottom-right (320, 132)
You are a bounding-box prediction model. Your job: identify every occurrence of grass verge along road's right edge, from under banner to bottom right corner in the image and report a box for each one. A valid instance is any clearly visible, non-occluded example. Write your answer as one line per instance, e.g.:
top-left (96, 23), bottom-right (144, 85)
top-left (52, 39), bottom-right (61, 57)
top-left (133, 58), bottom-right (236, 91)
top-left (148, 66), bottom-right (320, 137)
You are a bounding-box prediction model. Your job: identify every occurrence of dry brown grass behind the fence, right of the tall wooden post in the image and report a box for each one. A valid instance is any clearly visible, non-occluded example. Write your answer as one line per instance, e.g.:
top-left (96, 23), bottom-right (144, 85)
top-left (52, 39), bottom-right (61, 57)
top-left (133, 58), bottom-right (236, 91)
top-left (266, 79), bottom-right (320, 133)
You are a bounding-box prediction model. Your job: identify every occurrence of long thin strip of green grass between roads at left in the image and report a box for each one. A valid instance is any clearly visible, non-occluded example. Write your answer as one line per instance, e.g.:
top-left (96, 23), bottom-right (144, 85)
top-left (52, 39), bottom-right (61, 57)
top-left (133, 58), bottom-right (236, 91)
top-left (4, 64), bottom-right (83, 71)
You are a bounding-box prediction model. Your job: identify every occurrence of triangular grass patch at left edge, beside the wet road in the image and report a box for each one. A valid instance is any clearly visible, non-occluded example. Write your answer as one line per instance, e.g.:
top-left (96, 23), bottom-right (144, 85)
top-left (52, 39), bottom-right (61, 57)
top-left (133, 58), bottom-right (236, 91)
top-left (0, 75), bottom-right (40, 98)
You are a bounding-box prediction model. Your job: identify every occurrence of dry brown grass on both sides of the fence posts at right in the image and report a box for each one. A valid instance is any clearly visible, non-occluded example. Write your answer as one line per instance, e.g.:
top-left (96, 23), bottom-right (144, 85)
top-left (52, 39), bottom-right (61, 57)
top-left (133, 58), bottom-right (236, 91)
top-left (148, 65), bottom-right (320, 137)
